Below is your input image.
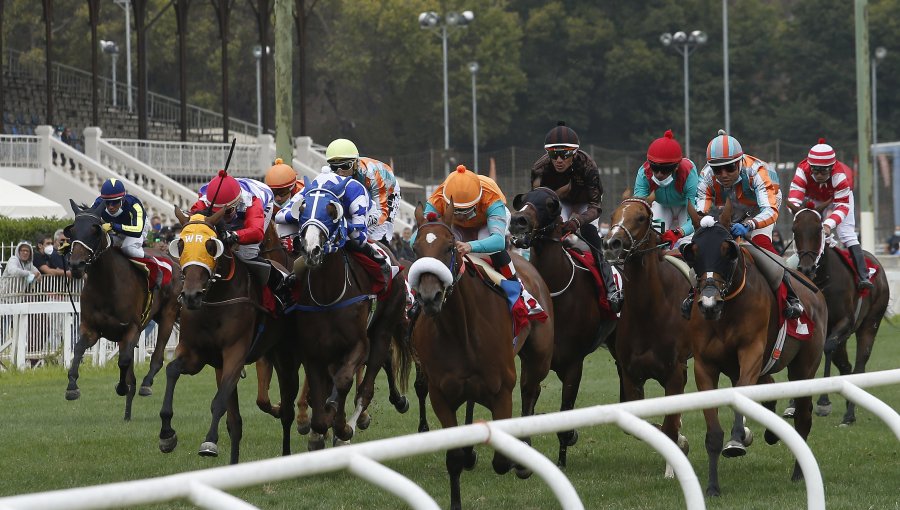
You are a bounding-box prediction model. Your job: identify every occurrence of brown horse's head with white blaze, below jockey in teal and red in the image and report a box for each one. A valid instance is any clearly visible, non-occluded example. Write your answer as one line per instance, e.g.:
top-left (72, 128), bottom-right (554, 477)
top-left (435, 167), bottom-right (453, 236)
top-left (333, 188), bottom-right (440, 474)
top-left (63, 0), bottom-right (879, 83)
top-left (603, 193), bottom-right (658, 263)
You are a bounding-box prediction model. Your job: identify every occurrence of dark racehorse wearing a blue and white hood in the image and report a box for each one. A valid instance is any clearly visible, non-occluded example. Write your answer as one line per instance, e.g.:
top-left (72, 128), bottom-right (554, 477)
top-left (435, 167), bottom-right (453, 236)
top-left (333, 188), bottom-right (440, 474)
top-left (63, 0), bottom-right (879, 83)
top-left (282, 179), bottom-right (412, 450)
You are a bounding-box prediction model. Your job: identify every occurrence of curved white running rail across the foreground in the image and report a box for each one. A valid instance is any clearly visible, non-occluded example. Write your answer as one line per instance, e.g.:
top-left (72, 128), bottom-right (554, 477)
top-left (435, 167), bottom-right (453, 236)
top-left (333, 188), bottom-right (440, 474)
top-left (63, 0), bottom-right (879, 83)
top-left (0, 369), bottom-right (900, 510)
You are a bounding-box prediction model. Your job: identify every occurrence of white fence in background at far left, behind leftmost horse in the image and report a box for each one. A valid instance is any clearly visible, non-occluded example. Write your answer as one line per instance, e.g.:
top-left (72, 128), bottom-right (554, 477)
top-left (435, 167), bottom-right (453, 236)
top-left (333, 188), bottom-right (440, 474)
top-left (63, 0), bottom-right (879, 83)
top-left (0, 276), bottom-right (178, 370)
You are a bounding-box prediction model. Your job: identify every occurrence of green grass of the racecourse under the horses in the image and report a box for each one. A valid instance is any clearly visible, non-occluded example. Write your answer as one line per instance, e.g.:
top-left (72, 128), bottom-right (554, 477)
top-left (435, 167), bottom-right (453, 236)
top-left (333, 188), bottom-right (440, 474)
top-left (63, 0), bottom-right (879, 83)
top-left (0, 323), bottom-right (900, 510)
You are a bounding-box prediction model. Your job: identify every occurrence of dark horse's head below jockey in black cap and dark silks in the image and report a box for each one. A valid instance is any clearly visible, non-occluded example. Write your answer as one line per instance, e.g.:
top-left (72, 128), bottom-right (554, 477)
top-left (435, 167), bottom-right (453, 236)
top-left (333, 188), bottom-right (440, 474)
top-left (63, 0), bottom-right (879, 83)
top-left (509, 187), bottom-right (562, 248)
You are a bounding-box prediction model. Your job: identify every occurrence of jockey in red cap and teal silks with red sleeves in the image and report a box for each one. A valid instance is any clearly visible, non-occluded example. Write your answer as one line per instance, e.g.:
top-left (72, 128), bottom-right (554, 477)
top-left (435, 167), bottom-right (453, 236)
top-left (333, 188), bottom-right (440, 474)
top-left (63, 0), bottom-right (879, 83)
top-left (634, 129), bottom-right (700, 248)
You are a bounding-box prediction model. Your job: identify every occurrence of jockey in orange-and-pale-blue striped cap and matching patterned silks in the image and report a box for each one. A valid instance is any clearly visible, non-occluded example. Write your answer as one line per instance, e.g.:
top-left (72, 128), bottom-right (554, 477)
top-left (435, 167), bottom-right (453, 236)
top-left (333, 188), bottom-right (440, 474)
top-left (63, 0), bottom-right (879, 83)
top-left (681, 130), bottom-right (803, 319)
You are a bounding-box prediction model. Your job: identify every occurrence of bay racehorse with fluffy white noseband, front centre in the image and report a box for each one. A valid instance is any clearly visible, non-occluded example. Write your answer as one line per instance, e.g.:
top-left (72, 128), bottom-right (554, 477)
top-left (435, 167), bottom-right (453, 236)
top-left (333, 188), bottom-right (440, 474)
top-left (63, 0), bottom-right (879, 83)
top-left (409, 203), bottom-right (553, 509)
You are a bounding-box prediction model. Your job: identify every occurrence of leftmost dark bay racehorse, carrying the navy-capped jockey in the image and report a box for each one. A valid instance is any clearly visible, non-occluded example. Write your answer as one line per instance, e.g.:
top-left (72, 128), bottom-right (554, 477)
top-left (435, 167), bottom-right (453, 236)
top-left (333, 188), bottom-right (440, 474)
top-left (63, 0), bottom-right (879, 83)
top-left (65, 200), bottom-right (181, 420)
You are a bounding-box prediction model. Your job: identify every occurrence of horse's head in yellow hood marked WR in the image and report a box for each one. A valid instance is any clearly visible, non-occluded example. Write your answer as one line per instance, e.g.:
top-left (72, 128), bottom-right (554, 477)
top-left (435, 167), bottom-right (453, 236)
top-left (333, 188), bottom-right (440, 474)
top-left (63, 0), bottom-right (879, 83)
top-left (169, 207), bottom-right (225, 310)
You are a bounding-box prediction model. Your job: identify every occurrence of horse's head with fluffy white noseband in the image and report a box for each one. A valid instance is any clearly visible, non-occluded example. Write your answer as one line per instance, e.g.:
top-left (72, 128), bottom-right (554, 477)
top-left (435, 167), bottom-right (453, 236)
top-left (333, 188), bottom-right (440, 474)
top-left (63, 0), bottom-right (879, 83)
top-left (407, 200), bottom-right (461, 316)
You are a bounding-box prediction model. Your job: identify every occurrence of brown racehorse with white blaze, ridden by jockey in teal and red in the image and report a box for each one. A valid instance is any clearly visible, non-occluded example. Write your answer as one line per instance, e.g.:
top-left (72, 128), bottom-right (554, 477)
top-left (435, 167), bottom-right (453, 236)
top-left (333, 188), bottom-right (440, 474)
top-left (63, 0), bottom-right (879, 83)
top-left (603, 193), bottom-right (691, 477)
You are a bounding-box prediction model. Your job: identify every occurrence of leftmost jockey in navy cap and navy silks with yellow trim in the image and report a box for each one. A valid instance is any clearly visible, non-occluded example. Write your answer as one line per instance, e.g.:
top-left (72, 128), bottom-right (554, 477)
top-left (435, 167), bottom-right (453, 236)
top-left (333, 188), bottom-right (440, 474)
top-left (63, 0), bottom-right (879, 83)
top-left (92, 179), bottom-right (150, 259)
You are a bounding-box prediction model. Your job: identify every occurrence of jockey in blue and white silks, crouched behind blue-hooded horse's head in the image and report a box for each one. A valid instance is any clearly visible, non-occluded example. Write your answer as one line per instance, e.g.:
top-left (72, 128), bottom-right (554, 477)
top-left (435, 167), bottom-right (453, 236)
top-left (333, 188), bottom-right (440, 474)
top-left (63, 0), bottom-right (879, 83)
top-left (275, 162), bottom-right (391, 284)
